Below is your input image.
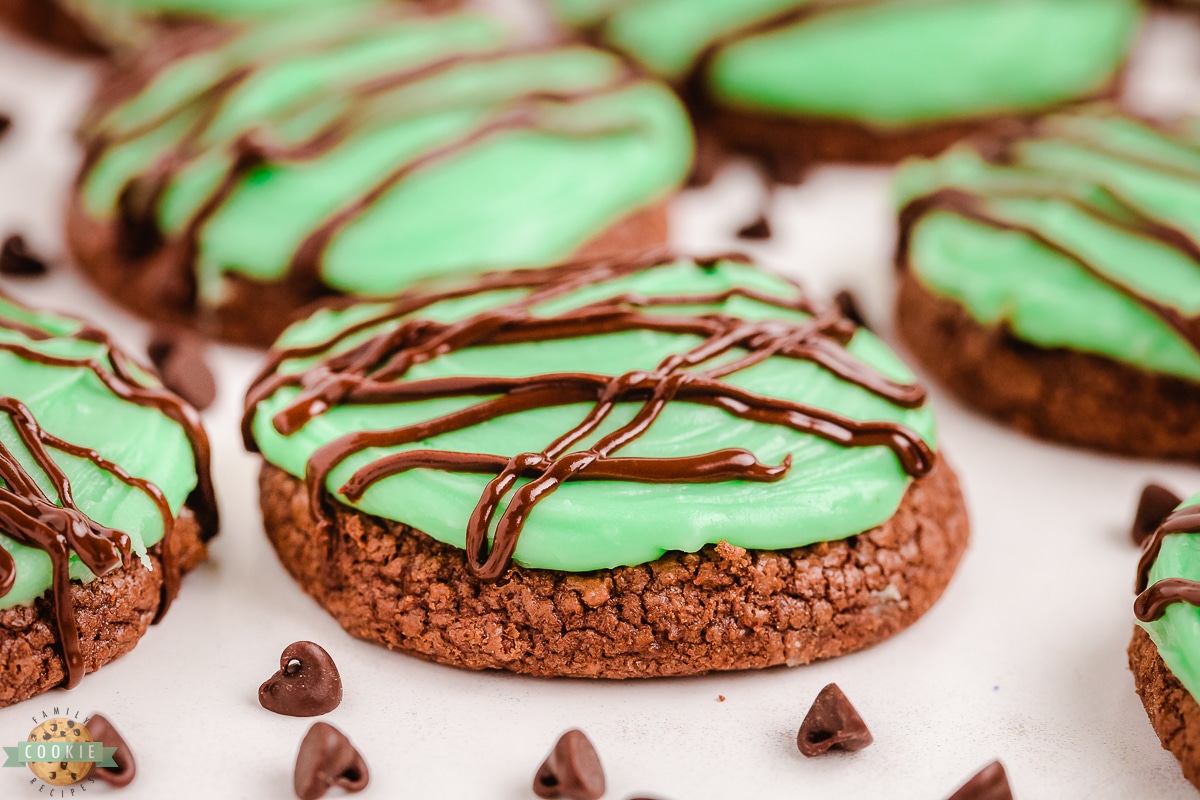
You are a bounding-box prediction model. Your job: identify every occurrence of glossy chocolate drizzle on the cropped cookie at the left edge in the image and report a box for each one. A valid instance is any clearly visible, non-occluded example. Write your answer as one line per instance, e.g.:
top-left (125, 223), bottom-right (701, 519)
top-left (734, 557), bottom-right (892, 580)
top-left (0, 297), bottom-right (218, 688)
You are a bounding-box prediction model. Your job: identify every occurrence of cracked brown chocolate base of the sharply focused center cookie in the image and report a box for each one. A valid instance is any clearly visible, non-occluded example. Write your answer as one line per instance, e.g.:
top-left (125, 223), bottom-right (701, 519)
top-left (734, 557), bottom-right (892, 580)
top-left (259, 462), bottom-right (968, 679)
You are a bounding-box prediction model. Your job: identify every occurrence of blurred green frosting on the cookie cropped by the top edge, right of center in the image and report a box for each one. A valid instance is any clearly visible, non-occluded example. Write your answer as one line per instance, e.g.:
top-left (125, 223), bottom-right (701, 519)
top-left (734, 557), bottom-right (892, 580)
top-left (551, 0), bottom-right (1142, 127)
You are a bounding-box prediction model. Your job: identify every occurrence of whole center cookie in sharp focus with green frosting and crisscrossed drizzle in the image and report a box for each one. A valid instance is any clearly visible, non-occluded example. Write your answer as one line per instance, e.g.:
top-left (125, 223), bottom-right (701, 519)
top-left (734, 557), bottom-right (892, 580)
top-left (244, 254), bottom-right (967, 678)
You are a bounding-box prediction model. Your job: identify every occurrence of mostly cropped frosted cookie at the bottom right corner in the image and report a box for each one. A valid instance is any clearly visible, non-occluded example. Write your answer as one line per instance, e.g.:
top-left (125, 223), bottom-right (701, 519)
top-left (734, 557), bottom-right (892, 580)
top-left (1129, 494), bottom-right (1200, 789)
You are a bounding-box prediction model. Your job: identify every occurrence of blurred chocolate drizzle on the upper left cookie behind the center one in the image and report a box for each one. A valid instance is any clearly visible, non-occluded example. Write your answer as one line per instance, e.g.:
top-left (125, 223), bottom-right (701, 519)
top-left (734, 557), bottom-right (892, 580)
top-left (78, 12), bottom-right (644, 307)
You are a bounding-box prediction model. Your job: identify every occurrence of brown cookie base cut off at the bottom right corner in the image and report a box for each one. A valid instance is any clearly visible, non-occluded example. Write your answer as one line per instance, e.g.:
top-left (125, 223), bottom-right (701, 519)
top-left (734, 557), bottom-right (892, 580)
top-left (1128, 626), bottom-right (1200, 789)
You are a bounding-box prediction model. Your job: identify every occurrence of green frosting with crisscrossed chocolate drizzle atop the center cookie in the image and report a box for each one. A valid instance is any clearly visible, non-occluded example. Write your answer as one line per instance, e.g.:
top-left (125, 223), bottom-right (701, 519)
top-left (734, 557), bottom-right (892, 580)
top-left (244, 255), bottom-right (936, 578)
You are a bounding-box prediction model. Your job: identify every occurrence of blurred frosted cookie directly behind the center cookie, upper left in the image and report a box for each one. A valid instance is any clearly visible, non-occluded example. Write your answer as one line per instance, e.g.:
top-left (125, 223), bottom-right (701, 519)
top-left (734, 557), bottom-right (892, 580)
top-left (67, 7), bottom-right (692, 345)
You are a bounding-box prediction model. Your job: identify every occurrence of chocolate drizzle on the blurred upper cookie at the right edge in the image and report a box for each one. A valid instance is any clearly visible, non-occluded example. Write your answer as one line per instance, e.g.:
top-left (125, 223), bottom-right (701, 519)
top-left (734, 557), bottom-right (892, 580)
top-left (895, 112), bottom-right (1200, 353)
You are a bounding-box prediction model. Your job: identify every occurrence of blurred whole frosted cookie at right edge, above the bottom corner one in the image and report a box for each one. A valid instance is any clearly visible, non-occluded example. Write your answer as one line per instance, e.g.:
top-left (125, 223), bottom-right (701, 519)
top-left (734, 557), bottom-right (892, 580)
top-left (895, 108), bottom-right (1200, 459)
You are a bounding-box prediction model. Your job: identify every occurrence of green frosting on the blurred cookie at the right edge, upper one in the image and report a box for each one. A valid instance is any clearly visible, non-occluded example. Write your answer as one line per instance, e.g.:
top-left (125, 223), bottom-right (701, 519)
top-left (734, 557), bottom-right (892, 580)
top-left (895, 108), bottom-right (1200, 380)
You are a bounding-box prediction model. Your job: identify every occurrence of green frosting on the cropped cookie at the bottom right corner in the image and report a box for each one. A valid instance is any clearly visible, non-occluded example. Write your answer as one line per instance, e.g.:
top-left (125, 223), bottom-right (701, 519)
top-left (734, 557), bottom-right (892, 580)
top-left (1138, 494), bottom-right (1200, 698)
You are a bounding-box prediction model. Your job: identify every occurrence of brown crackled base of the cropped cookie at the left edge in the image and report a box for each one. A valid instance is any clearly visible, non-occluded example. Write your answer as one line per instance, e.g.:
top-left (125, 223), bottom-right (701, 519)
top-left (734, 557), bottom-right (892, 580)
top-left (0, 513), bottom-right (206, 708)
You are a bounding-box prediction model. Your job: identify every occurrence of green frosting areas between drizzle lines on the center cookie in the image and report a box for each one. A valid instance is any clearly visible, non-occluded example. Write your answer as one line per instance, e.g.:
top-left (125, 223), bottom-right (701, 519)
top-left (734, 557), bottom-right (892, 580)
top-left (252, 261), bottom-right (935, 571)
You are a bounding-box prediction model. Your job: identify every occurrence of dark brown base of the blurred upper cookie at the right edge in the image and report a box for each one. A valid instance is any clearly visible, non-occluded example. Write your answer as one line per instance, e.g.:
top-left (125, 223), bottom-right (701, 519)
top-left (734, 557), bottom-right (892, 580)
top-left (896, 270), bottom-right (1200, 461)
